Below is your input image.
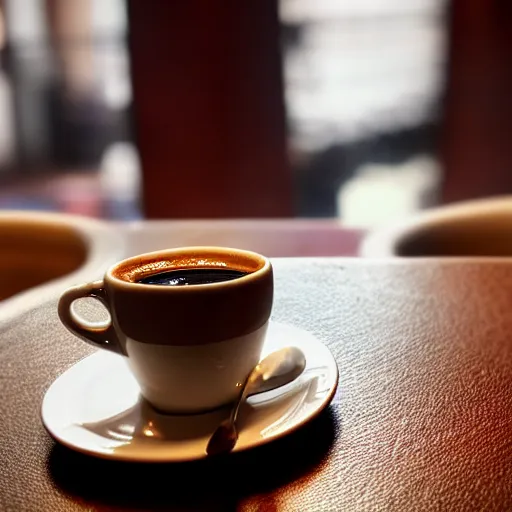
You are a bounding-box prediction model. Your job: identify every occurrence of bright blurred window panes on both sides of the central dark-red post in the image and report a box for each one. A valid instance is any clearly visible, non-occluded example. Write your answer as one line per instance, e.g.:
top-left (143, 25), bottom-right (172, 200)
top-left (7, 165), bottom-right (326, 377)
top-left (0, 0), bottom-right (447, 226)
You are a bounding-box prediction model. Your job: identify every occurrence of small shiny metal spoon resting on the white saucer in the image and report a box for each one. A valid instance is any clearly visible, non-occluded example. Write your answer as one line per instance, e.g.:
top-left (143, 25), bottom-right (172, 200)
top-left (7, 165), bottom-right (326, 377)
top-left (206, 347), bottom-right (306, 455)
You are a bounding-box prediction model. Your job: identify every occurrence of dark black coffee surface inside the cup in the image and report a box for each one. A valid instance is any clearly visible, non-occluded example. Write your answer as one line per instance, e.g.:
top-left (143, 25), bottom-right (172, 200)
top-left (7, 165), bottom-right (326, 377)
top-left (137, 268), bottom-right (248, 286)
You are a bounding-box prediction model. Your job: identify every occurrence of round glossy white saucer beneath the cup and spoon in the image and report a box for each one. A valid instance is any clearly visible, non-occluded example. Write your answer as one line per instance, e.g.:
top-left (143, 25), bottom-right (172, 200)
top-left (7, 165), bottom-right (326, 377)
top-left (41, 322), bottom-right (338, 462)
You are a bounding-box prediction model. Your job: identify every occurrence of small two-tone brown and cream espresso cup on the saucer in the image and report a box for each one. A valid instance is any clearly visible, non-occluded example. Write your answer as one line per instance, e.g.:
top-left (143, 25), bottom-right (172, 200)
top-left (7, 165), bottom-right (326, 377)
top-left (58, 247), bottom-right (273, 413)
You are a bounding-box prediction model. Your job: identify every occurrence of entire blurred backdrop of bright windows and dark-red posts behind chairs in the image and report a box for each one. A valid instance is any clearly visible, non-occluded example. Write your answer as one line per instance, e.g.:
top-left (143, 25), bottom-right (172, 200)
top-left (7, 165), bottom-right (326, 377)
top-left (0, 0), bottom-right (512, 227)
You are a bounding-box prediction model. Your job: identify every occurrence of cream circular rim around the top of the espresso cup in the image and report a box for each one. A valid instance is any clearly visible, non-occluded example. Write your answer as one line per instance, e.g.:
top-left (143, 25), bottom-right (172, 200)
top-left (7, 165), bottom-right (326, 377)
top-left (105, 245), bottom-right (272, 293)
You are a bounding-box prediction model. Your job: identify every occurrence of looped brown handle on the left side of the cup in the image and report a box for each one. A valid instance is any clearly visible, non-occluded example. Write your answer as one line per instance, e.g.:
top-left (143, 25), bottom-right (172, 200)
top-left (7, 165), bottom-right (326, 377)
top-left (58, 281), bottom-right (126, 355)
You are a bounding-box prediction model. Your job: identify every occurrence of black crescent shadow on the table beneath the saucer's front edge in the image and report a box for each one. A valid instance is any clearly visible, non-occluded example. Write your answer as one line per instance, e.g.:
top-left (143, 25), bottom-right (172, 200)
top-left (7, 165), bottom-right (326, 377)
top-left (47, 405), bottom-right (340, 511)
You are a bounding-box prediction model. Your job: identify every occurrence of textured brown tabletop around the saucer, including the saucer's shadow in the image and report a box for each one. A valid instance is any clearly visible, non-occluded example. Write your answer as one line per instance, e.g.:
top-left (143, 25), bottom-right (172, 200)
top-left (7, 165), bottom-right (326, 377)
top-left (0, 258), bottom-right (512, 512)
